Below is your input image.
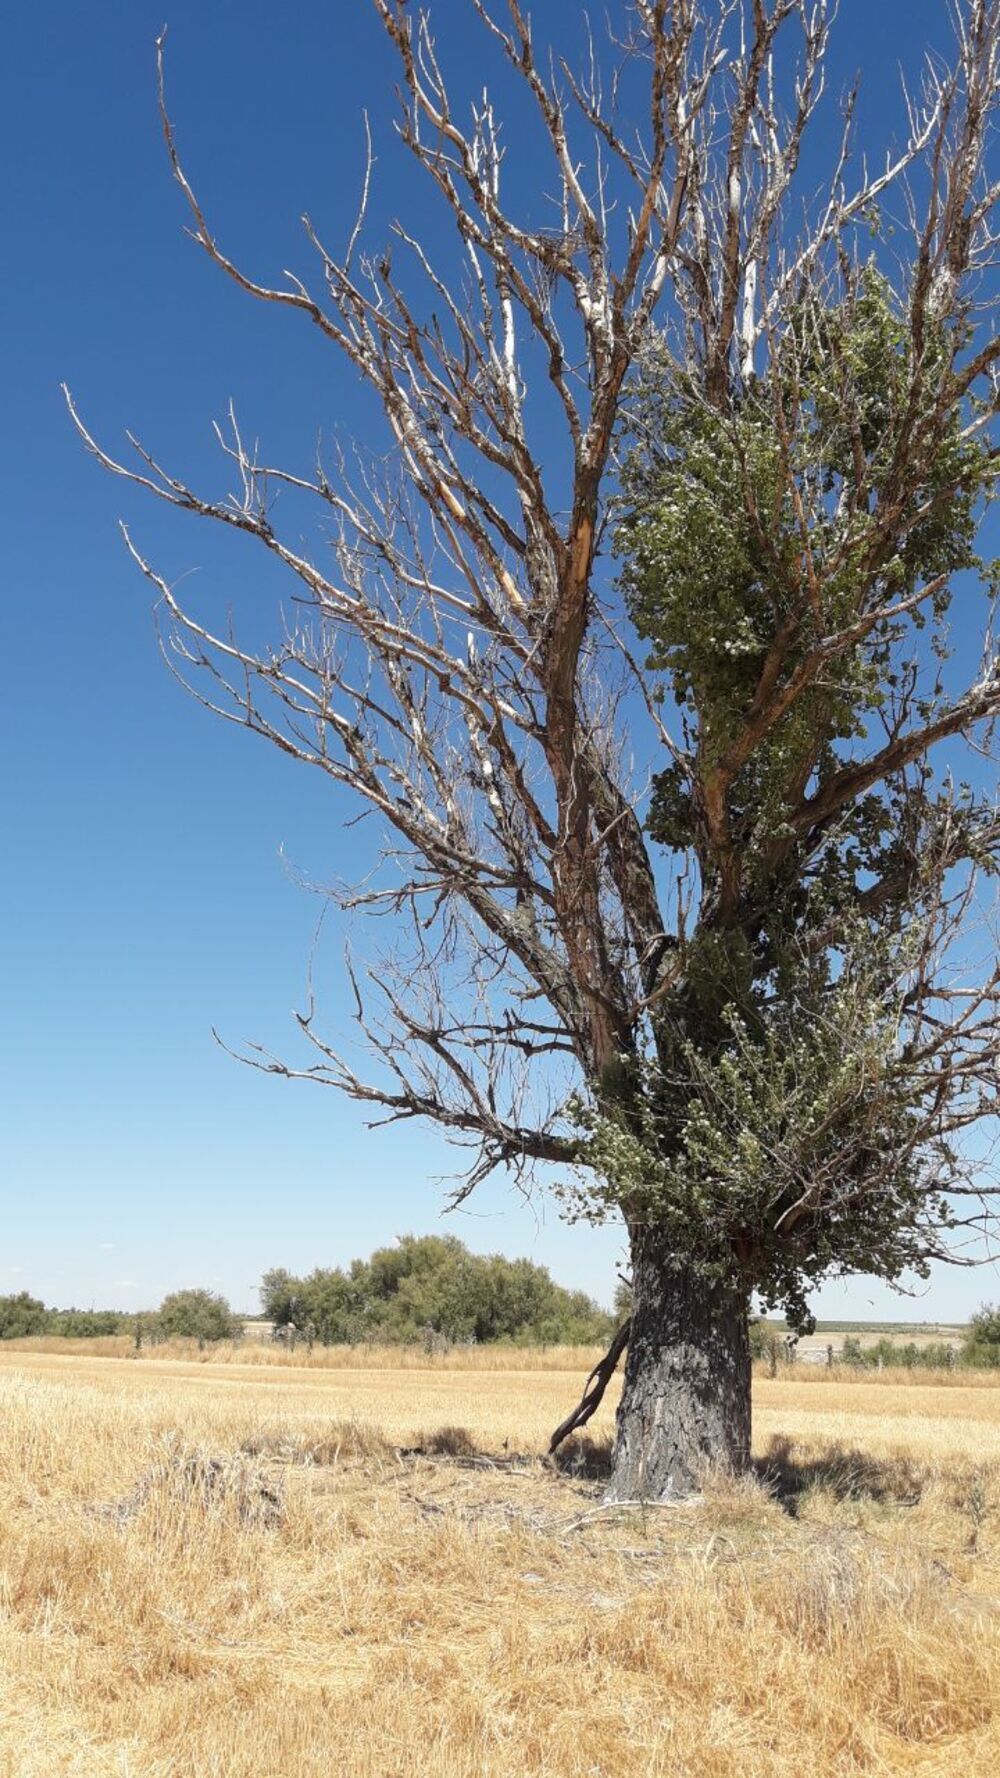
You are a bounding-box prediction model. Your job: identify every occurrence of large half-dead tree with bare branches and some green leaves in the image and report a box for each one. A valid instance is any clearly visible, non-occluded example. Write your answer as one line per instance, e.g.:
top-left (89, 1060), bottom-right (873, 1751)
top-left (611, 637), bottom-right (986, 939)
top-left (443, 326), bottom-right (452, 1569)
top-left (77, 0), bottom-right (1000, 1499)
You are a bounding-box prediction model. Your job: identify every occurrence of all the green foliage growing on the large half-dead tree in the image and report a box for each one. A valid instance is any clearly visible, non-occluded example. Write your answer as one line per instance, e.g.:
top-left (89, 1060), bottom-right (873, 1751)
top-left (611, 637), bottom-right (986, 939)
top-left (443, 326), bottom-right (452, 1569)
top-left (583, 267), bottom-right (995, 1330)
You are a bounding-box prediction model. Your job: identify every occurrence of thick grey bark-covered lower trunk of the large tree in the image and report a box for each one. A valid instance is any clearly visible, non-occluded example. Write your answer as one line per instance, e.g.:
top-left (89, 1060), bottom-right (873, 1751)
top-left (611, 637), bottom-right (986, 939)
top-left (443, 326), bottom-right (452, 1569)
top-left (607, 1230), bottom-right (751, 1501)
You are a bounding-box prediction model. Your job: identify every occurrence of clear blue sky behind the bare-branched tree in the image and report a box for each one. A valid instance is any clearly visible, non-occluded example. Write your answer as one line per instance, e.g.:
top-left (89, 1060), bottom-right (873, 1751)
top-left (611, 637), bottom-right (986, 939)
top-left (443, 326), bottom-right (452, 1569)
top-left (0, 0), bottom-right (1000, 1319)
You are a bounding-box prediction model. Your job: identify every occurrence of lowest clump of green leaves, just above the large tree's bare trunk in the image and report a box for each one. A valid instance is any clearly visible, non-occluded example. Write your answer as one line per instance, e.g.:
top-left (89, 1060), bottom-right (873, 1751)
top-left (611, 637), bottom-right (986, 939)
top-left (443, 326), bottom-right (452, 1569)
top-left (560, 939), bottom-right (950, 1332)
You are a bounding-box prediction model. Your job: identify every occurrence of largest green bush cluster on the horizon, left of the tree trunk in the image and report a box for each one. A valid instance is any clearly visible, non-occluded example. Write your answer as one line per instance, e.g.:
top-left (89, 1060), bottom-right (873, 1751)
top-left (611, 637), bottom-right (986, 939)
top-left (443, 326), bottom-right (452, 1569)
top-left (260, 1236), bottom-right (614, 1346)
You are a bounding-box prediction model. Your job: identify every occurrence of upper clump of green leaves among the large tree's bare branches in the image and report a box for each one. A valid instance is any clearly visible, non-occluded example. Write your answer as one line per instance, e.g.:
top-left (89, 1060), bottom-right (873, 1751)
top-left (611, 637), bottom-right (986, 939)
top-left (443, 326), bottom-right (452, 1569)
top-left (617, 268), bottom-right (995, 873)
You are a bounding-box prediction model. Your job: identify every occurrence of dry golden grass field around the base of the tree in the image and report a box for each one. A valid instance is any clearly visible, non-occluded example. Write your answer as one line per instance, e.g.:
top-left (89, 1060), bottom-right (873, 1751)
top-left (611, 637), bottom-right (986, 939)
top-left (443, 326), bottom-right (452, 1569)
top-left (0, 1348), bottom-right (1000, 1778)
